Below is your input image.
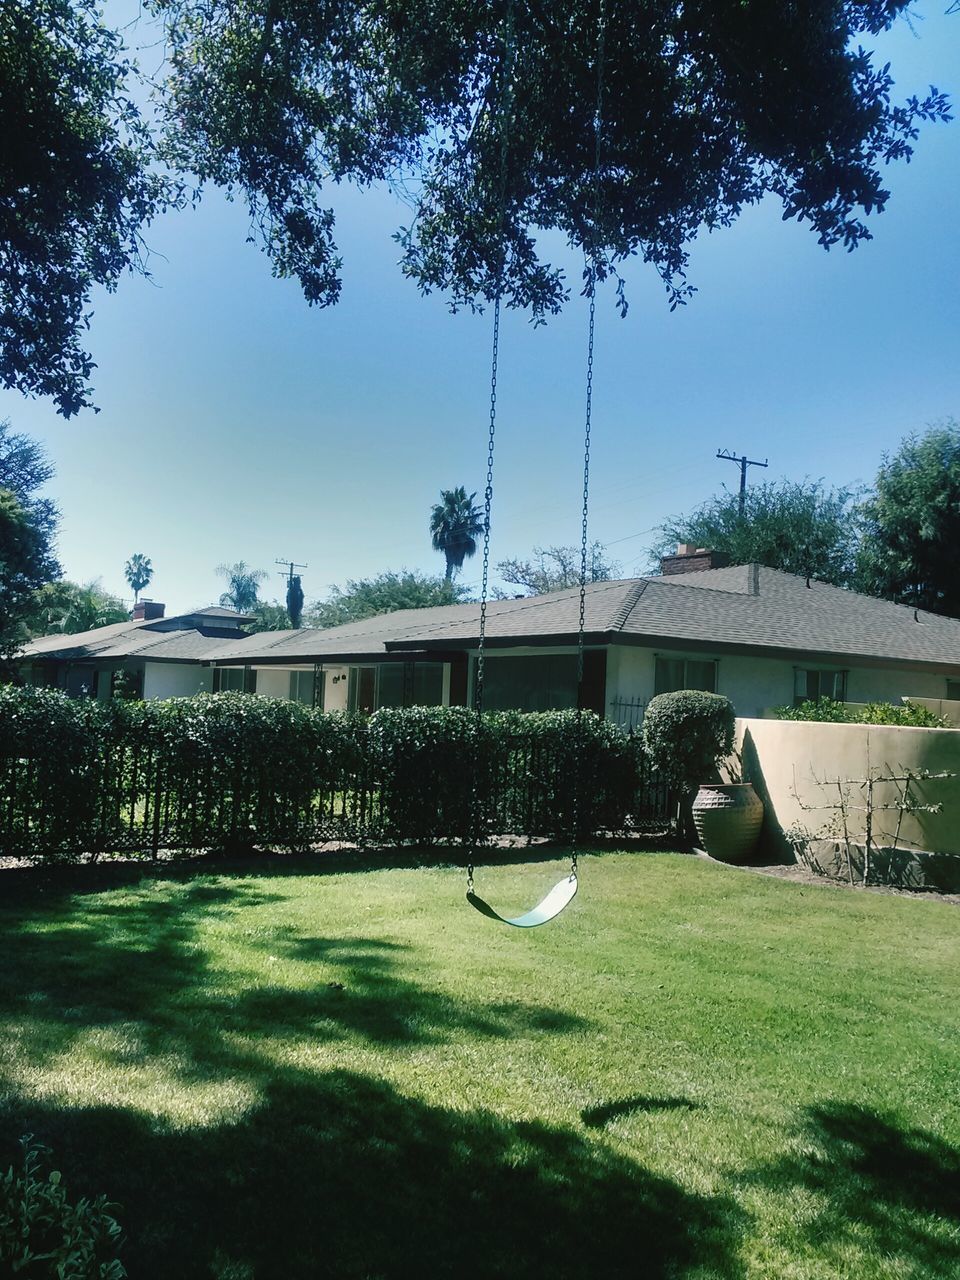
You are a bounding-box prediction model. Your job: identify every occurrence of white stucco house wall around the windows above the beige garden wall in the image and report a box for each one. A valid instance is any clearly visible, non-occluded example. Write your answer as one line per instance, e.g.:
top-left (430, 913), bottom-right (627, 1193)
top-left (607, 645), bottom-right (946, 717)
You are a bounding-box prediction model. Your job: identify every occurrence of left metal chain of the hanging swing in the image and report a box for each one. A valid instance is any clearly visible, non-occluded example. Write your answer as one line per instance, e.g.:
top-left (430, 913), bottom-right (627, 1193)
top-left (467, 0), bottom-right (513, 893)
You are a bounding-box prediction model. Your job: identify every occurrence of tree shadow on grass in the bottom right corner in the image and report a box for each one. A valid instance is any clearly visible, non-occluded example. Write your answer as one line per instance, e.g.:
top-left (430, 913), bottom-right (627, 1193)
top-left (748, 1102), bottom-right (960, 1280)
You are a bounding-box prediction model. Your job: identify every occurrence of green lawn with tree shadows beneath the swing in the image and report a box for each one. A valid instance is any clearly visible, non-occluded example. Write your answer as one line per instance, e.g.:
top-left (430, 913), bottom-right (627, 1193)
top-left (0, 854), bottom-right (960, 1280)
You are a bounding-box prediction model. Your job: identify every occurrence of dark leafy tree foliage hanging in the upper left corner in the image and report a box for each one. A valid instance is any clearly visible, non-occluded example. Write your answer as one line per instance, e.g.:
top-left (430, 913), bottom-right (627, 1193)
top-left (0, 0), bottom-right (177, 417)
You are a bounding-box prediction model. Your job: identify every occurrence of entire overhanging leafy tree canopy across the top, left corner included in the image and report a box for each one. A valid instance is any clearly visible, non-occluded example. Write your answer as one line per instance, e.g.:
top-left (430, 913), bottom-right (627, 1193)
top-left (0, 0), bottom-right (948, 415)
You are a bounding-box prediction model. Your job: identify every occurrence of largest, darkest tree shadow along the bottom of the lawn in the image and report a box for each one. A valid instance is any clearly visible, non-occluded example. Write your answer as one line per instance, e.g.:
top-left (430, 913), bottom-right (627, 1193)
top-left (0, 1071), bottom-right (741, 1280)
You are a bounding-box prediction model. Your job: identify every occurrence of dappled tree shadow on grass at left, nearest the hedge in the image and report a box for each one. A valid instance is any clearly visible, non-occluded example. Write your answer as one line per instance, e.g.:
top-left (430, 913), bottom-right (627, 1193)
top-left (0, 882), bottom-right (599, 1085)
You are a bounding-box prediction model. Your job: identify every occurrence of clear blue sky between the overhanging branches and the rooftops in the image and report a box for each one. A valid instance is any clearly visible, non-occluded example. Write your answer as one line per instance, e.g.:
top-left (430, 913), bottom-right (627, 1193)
top-left (0, 0), bottom-right (960, 609)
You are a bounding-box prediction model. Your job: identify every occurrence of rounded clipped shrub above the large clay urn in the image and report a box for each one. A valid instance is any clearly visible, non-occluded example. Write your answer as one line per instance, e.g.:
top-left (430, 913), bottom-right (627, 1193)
top-left (643, 689), bottom-right (735, 788)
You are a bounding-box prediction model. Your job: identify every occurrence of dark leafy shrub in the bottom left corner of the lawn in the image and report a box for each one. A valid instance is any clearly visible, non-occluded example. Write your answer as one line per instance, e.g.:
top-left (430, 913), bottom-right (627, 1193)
top-left (0, 1135), bottom-right (127, 1280)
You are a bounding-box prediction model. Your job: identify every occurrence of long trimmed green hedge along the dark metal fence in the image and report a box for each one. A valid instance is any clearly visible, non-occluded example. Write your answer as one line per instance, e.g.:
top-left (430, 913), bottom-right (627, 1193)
top-left (0, 686), bottom-right (660, 860)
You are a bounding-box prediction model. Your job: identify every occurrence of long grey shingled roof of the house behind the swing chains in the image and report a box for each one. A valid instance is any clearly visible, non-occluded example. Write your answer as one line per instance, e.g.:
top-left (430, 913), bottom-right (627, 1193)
top-left (207, 564), bottom-right (960, 673)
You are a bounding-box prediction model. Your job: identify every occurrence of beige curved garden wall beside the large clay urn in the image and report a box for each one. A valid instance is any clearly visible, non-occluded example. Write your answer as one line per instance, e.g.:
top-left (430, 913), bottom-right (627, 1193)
top-left (737, 719), bottom-right (960, 855)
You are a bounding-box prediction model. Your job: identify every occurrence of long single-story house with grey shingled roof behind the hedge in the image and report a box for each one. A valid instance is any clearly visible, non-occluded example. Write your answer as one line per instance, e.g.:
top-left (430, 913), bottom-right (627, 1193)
top-left (16, 550), bottom-right (960, 726)
